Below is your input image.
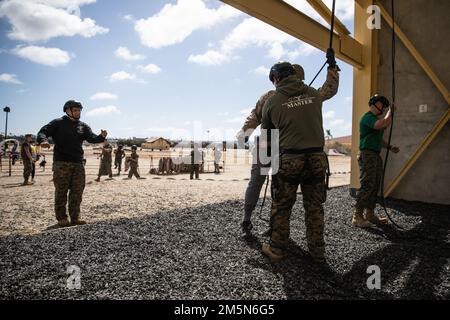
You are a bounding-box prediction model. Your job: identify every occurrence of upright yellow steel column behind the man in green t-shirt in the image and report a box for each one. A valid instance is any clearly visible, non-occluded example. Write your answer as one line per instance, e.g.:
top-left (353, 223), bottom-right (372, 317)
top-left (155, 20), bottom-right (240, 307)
top-left (350, 0), bottom-right (379, 188)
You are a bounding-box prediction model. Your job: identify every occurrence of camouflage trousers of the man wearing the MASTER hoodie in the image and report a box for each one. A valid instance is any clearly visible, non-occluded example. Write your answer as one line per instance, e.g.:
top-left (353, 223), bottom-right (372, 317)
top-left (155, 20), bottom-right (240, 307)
top-left (270, 153), bottom-right (327, 258)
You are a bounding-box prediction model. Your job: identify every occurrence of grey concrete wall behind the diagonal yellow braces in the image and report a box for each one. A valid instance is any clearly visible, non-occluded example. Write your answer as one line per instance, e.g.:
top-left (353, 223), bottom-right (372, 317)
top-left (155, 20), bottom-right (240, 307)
top-left (378, 0), bottom-right (450, 204)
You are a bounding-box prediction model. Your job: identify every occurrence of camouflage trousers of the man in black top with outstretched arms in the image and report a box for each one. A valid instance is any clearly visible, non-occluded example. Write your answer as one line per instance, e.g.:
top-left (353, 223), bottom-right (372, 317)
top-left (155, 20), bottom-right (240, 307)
top-left (53, 161), bottom-right (85, 220)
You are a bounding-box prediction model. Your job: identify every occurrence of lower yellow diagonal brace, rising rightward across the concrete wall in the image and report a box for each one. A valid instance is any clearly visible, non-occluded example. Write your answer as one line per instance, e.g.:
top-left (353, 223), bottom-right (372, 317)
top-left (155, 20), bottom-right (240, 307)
top-left (384, 109), bottom-right (450, 197)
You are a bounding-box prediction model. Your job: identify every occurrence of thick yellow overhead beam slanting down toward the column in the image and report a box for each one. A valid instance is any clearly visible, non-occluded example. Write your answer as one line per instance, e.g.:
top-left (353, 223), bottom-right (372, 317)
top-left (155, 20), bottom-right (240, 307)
top-left (221, 0), bottom-right (363, 69)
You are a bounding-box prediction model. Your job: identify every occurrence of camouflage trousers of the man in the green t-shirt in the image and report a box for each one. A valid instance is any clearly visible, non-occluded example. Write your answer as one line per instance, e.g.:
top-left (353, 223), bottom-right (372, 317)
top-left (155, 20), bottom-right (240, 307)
top-left (356, 150), bottom-right (383, 209)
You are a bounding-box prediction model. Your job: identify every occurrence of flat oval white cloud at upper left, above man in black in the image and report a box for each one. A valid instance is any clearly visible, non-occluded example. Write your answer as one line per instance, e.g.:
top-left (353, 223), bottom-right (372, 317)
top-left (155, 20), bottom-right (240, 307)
top-left (13, 46), bottom-right (70, 67)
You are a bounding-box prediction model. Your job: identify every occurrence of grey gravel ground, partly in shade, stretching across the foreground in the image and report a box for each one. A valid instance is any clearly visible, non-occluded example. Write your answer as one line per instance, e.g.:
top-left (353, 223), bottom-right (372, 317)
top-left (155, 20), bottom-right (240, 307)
top-left (0, 185), bottom-right (450, 299)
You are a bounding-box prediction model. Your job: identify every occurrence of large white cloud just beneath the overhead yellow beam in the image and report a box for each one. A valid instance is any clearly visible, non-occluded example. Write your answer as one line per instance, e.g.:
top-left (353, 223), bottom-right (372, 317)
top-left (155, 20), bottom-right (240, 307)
top-left (189, 18), bottom-right (320, 65)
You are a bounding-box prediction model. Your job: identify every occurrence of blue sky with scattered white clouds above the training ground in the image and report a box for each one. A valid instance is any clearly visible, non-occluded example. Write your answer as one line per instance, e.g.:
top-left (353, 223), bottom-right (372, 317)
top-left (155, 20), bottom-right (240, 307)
top-left (0, 0), bottom-right (354, 140)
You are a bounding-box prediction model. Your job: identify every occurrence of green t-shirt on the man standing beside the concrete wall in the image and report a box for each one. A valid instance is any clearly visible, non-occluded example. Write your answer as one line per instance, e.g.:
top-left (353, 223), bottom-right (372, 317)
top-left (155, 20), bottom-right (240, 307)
top-left (359, 111), bottom-right (384, 152)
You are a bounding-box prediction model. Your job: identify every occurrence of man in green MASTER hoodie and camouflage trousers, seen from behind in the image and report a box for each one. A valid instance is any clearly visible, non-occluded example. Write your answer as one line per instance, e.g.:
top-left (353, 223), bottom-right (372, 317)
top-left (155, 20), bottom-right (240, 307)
top-left (262, 54), bottom-right (339, 263)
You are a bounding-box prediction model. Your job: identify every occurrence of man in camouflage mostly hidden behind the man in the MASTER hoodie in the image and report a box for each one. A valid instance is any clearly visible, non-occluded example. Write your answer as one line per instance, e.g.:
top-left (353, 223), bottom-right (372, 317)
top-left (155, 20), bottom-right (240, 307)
top-left (237, 64), bottom-right (339, 236)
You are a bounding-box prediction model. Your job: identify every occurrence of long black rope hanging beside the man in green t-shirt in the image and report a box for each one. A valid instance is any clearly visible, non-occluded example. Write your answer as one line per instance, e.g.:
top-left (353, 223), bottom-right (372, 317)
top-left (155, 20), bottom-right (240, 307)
top-left (381, 0), bottom-right (405, 230)
